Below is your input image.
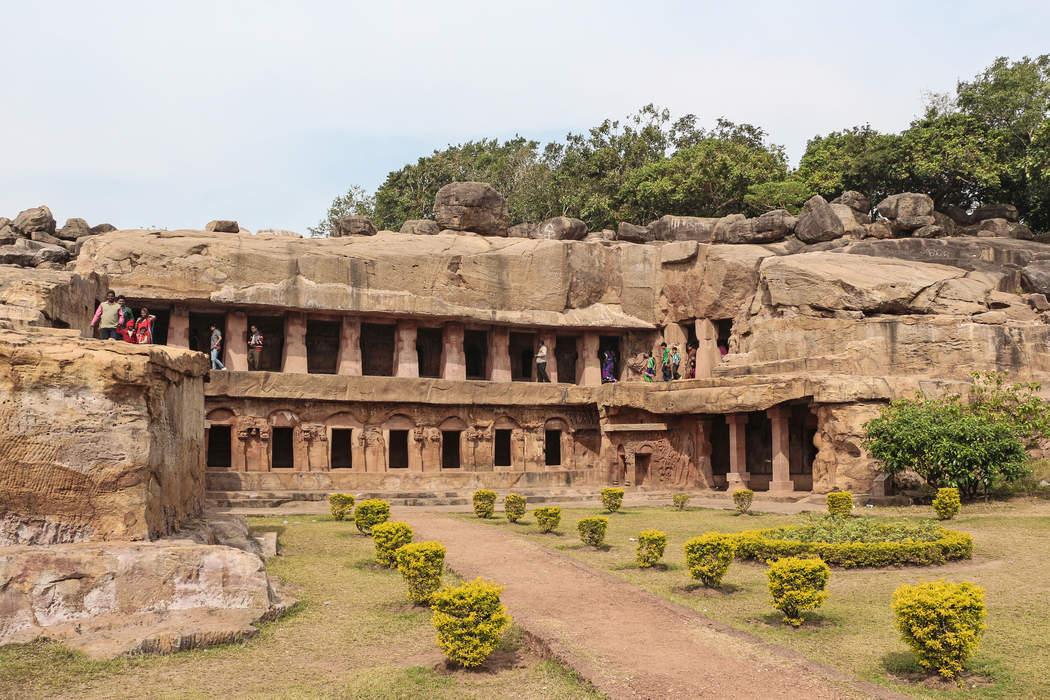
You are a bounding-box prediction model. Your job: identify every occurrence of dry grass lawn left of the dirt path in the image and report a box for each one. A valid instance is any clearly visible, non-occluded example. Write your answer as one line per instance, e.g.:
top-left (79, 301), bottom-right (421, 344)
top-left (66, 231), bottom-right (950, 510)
top-left (0, 515), bottom-right (597, 699)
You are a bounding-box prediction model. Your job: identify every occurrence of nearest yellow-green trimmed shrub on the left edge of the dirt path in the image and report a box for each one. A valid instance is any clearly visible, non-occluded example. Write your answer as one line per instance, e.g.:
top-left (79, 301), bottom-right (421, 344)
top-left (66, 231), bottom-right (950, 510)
top-left (431, 578), bottom-right (510, 669)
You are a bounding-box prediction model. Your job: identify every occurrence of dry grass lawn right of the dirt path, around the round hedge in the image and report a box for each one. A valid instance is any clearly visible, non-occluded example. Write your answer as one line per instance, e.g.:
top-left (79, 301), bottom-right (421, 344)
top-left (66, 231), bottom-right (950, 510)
top-left (463, 500), bottom-right (1050, 698)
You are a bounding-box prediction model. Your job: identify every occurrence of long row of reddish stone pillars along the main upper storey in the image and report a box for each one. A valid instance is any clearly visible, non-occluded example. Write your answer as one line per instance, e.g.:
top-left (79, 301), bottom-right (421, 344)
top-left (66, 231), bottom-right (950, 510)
top-left (168, 310), bottom-right (602, 386)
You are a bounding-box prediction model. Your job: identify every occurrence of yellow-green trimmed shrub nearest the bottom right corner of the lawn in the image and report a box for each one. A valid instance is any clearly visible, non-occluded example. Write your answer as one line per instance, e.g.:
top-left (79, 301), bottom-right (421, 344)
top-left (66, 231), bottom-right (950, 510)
top-left (890, 580), bottom-right (985, 678)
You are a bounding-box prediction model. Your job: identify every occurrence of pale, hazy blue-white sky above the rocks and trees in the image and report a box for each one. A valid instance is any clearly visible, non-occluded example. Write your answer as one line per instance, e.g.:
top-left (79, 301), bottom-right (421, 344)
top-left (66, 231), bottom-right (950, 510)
top-left (0, 0), bottom-right (1050, 232)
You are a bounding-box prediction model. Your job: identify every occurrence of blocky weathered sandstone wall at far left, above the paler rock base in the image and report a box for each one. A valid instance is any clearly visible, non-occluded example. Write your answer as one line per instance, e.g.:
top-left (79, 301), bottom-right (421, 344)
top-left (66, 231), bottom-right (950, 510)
top-left (0, 330), bottom-right (206, 545)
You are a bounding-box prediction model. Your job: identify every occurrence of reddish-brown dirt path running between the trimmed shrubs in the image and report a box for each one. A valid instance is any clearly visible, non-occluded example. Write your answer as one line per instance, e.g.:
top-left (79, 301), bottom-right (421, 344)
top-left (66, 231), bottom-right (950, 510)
top-left (395, 508), bottom-right (903, 699)
